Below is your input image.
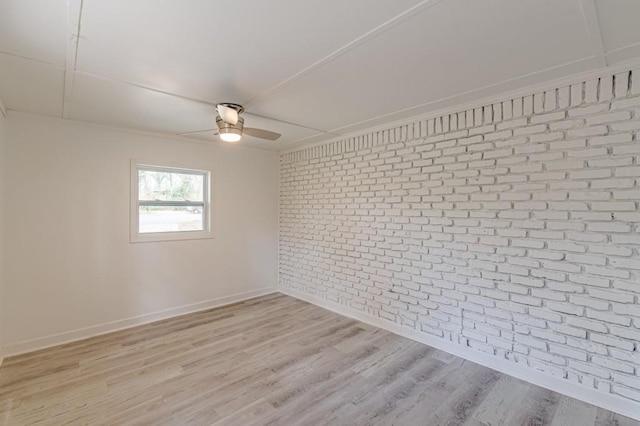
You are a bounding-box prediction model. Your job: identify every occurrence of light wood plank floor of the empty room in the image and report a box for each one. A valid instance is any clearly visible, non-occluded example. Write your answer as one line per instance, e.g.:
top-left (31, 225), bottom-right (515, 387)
top-left (0, 294), bottom-right (640, 426)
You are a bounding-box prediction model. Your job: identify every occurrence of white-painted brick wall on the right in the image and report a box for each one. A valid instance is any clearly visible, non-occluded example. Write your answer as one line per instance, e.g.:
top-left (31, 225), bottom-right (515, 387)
top-left (280, 70), bottom-right (640, 402)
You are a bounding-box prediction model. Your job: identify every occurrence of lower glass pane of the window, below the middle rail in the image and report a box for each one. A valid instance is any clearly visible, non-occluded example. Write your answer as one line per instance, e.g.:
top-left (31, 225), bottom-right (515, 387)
top-left (138, 206), bottom-right (204, 234)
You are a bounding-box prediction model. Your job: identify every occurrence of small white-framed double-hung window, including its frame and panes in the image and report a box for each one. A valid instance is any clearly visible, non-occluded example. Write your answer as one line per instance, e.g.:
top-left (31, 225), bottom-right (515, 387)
top-left (131, 161), bottom-right (213, 242)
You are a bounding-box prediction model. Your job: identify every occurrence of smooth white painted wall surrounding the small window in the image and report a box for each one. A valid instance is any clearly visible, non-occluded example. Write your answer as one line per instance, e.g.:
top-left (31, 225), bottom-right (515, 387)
top-left (0, 112), bottom-right (278, 354)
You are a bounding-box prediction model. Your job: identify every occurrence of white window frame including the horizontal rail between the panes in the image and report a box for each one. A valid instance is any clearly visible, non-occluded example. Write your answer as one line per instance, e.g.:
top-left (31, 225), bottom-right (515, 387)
top-left (129, 159), bottom-right (213, 243)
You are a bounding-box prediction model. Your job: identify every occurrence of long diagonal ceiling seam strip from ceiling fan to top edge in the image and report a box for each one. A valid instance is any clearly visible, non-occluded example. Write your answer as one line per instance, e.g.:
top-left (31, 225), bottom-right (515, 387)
top-left (245, 0), bottom-right (444, 105)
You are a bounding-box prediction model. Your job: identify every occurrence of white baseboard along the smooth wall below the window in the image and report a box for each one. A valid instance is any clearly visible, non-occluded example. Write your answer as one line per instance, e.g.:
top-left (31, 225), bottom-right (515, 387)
top-left (0, 288), bottom-right (278, 365)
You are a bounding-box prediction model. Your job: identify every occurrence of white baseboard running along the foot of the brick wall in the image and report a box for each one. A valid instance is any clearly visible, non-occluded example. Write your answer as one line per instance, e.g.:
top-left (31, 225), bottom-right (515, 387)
top-left (279, 288), bottom-right (640, 420)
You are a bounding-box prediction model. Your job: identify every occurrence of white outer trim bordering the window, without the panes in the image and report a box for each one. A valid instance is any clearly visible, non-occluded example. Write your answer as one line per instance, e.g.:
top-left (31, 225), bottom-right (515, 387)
top-left (129, 159), bottom-right (213, 243)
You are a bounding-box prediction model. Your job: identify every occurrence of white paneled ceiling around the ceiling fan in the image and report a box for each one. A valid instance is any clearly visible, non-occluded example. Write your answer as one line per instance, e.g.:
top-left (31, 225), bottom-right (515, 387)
top-left (0, 0), bottom-right (640, 150)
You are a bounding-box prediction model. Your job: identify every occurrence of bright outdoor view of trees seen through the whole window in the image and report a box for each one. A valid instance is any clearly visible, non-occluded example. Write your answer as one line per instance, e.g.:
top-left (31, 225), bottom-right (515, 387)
top-left (138, 166), bottom-right (207, 233)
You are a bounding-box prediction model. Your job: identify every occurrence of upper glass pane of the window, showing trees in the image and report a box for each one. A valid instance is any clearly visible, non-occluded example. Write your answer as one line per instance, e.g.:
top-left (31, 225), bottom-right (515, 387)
top-left (138, 169), bottom-right (205, 201)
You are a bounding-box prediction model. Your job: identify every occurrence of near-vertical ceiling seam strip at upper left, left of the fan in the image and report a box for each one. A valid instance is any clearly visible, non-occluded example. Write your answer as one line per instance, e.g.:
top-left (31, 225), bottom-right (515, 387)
top-left (62, 0), bottom-right (84, 118)
